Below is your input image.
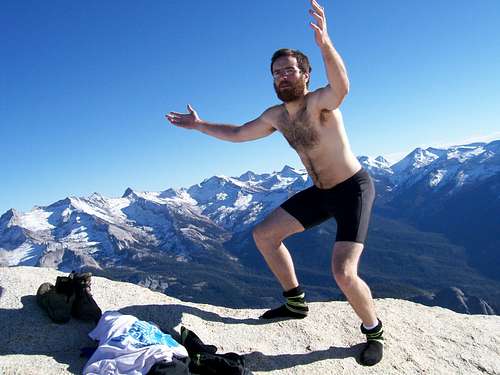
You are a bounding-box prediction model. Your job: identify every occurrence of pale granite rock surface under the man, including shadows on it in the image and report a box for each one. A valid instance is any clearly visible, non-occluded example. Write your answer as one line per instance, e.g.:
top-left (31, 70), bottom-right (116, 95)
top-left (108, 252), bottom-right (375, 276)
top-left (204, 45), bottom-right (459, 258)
top-left (0, 267), bottom-right (500, 375)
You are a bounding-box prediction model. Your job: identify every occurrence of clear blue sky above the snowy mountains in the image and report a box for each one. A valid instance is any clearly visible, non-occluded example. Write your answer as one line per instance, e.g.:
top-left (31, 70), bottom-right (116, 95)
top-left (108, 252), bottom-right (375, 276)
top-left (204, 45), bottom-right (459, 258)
top-left (0, 0), bottom-right (500, 214)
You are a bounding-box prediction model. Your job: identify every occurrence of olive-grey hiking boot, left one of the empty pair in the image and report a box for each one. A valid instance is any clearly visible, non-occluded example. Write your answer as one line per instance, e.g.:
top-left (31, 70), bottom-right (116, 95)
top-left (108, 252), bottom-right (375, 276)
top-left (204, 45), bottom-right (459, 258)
top-left (36, 283), bottom-right (75, 324)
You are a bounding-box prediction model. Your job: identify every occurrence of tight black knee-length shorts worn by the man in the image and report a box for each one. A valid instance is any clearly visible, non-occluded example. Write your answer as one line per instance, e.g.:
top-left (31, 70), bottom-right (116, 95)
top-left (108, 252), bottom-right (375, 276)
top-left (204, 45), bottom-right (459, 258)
top-left (281, 169), bottom-right (375, 243)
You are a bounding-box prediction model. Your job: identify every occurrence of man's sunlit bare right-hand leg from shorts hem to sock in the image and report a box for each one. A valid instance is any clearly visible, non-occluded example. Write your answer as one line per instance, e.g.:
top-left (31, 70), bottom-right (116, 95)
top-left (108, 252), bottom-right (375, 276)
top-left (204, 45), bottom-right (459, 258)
top-left (332, 242), bottom-right (378, 326)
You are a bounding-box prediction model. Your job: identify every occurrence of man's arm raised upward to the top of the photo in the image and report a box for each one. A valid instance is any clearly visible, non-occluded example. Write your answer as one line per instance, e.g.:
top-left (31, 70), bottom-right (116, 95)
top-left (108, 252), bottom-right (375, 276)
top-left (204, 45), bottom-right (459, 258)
top-left (309, 0), bottom-right (349, 109)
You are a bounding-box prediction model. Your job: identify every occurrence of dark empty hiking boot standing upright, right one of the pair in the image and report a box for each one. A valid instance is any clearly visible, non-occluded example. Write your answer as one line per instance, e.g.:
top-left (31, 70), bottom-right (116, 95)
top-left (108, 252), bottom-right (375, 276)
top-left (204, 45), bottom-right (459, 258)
top-left (69, 271), bottom-right (102, 324)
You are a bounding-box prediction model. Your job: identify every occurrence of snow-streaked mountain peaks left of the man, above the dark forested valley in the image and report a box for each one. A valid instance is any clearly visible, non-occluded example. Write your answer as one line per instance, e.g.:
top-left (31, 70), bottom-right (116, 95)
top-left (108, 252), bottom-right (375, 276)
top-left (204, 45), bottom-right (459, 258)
top-left (0, 166), bottom-right (310, 270)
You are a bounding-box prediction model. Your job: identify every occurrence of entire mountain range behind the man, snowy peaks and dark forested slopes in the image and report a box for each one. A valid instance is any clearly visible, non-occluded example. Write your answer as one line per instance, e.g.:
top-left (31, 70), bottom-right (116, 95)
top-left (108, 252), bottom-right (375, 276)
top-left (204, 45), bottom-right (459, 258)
top-left (0, 141), bottom-right (500, 314)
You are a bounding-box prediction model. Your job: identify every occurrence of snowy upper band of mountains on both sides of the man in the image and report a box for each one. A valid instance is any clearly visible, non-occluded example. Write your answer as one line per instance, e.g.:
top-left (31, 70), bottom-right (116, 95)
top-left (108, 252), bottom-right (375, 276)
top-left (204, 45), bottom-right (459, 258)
top-left (0, 141), bottom-right (500, 269)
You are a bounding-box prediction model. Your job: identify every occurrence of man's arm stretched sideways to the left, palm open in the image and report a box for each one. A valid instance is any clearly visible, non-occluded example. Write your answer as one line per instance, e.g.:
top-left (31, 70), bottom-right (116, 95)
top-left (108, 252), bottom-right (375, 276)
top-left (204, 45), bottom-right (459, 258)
top-left (165, 105), bottom-right (276, 142)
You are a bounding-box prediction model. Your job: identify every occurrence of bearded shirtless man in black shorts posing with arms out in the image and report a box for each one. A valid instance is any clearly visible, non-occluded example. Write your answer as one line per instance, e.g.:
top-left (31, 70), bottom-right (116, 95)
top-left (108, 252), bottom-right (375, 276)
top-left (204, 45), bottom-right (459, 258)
top-left (166, 0), bottom-right (383, 365)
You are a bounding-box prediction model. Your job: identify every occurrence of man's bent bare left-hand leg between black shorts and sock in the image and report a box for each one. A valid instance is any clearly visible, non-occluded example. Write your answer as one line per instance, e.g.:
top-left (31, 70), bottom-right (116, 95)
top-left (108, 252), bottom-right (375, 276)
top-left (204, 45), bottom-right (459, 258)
top-left (253, 207), bottom-right (304, 291)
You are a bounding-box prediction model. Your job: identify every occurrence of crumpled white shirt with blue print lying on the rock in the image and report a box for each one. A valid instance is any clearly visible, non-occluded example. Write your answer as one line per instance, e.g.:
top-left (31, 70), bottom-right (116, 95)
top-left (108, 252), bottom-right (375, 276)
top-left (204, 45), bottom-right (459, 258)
top-left (83, 311), bottom-right (188, 375)
